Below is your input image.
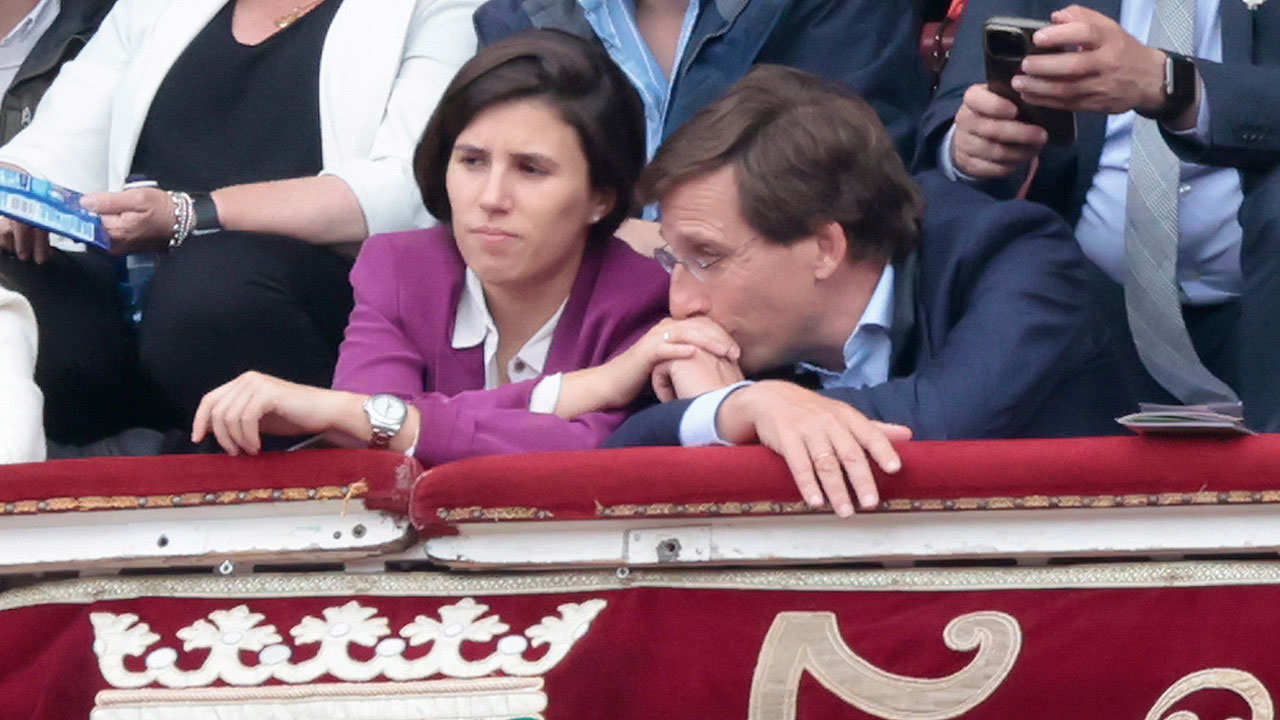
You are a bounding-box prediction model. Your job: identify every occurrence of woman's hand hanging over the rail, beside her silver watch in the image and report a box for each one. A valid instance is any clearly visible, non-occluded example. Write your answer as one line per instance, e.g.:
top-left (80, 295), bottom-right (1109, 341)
top-left (191, 370), bottom-right (355, 455)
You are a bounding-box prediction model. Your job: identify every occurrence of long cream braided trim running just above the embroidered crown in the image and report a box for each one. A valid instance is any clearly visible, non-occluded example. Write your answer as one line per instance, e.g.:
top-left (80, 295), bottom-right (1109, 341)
top-left (0, 560), bottom-right (1280, 611)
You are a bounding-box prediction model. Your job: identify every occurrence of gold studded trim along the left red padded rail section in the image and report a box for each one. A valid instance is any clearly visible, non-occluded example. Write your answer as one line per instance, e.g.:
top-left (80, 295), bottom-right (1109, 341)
top-left (0, 480), bottom-right (369, 516)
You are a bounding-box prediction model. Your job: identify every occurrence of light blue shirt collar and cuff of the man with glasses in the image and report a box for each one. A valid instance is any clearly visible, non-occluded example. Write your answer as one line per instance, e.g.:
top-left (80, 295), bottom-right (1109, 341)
top-left (680, 265), bottom-right (893, 447)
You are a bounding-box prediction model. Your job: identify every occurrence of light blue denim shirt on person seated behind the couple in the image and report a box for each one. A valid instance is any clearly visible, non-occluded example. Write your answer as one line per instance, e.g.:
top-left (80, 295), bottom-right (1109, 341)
top-left (577, 0), bottom-right (701, 159)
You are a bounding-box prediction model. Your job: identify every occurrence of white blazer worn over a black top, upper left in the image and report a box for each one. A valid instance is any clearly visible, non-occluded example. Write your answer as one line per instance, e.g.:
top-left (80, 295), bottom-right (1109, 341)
top-left (0, 0), bottom-right (481, 234)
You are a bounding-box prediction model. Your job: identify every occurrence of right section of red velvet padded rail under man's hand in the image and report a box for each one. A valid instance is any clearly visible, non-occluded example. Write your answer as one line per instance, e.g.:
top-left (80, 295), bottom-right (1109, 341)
top-left (410, 434), bottom-right (1280, 532)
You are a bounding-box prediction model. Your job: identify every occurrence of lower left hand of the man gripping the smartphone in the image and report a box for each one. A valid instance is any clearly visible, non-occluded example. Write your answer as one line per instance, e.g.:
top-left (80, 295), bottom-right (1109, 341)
top-left (951, 85), bottom-right (1048, 178)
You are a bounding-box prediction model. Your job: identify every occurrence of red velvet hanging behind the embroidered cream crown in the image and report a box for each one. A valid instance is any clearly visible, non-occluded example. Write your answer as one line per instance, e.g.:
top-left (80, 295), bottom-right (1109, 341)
top-left (0, 566), bottom-right (1280, 720)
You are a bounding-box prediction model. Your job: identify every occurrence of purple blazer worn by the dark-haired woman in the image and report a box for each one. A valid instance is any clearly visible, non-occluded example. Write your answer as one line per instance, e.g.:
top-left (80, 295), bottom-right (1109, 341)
top-left (333, 225), bottom-right (669, 465)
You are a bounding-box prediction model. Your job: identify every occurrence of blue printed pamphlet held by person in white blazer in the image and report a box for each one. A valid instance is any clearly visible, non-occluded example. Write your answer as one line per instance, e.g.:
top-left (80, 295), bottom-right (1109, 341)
top-left (0, 168), bottom-right (111, 250)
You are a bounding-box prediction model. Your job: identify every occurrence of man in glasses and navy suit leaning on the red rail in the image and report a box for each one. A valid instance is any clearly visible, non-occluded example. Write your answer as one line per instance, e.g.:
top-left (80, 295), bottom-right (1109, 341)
top-left (609, 65), bottom-right (1130, 515)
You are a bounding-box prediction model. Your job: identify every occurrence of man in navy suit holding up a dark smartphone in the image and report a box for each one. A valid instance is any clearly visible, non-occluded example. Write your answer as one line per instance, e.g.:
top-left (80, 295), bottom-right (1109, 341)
top-left (915, 0), bottom-right (1280, 432)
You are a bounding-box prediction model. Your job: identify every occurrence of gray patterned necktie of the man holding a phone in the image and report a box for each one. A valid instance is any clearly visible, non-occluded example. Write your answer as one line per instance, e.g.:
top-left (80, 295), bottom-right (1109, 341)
top-left (1124, 0), bottom-right (1239, 405)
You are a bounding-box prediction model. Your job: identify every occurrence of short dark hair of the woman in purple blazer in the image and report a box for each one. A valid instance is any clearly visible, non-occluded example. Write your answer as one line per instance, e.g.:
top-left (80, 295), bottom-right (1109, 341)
top-left (413, 29), bottom-right (645, 240)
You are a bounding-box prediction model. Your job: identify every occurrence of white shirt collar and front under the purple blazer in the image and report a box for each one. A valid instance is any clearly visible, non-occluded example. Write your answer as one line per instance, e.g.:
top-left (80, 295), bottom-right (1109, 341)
top-left (451, 268), bottom-right (568, 414)
